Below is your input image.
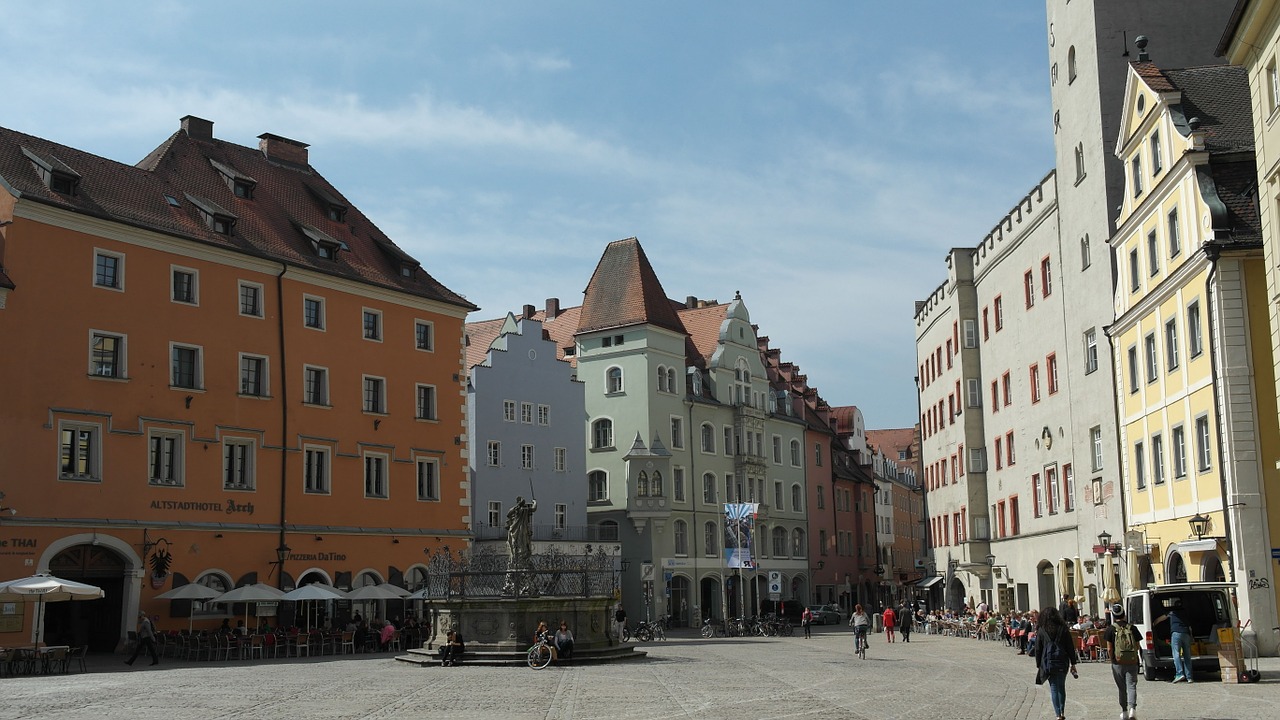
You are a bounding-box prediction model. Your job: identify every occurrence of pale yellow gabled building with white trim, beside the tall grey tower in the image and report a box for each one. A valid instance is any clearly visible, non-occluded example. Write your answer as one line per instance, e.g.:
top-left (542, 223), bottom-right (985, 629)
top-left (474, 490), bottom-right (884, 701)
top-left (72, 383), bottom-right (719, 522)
top-left (1108, 53), bottom-right (1277, 650)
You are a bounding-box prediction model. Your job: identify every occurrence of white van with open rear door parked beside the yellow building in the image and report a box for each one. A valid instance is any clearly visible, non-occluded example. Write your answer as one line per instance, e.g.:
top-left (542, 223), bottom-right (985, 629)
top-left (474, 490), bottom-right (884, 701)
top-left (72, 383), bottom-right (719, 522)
top-left (1124, 583), bottom-right (1236, 680)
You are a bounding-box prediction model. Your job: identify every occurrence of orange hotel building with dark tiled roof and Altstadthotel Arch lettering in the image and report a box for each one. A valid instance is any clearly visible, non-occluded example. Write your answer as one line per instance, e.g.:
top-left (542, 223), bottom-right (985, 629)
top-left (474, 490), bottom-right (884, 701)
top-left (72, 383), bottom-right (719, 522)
top-left (0, 117), bottom-right (475, 650)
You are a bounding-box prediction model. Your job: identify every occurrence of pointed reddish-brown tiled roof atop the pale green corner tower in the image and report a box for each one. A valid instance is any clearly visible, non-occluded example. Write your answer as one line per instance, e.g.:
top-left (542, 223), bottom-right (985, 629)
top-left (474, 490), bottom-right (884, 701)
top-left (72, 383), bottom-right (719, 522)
top-left (577, 237), bottom-right (685, 334)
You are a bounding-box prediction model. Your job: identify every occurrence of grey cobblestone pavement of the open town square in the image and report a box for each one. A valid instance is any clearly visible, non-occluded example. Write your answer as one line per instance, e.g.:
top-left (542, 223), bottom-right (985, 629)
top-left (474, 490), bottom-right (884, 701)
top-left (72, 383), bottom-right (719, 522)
top-left (0, 626), bottom-right (1280, 720)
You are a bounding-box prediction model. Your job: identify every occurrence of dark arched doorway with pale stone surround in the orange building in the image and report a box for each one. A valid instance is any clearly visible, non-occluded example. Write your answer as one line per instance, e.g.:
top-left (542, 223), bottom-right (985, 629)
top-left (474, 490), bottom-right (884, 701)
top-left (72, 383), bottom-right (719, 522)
top-left (45, 544), bottom-right (128, 652)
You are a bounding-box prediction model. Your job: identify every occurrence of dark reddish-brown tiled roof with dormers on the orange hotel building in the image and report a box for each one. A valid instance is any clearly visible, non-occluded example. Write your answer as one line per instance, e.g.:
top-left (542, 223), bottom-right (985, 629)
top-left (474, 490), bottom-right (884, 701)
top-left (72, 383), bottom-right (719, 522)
top-left (0, 115), bottom-right (476, 311)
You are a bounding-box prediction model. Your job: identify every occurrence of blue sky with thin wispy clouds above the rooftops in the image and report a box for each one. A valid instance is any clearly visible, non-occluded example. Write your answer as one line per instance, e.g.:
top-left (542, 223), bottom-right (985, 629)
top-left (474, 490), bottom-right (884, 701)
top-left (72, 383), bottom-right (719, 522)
top-left (0, 0), bottom-right (1053, 428)
